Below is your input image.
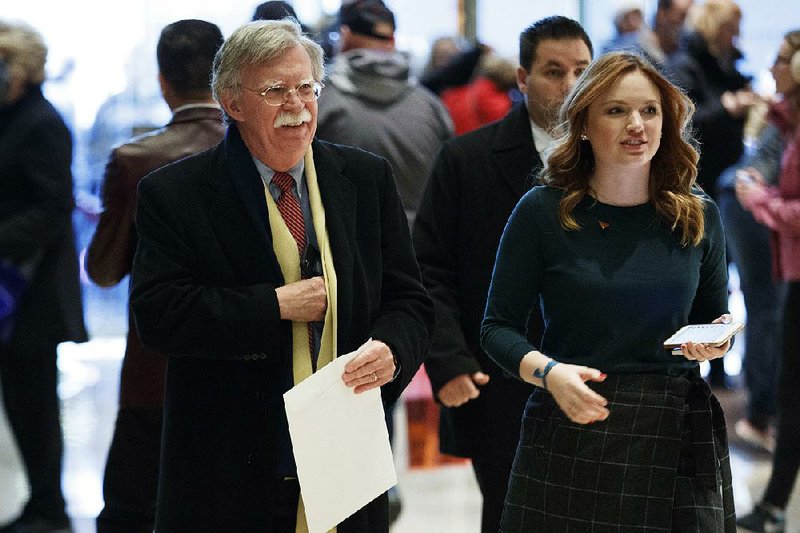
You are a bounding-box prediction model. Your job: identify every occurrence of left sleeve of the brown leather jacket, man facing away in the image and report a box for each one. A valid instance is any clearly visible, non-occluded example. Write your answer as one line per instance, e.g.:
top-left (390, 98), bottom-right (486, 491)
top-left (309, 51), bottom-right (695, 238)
top-left (86, 150), bottom-right (136, 287)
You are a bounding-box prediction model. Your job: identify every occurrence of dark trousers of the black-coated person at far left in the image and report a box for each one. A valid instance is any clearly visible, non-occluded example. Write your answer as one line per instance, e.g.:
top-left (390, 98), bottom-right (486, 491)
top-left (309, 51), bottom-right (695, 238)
top-left (0, 343), bottom-right (67, 524)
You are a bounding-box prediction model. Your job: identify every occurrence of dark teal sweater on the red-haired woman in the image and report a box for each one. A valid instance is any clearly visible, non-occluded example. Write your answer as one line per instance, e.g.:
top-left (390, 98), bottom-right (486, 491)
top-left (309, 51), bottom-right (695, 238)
top-left (481, 187), bottom-right (728, 376)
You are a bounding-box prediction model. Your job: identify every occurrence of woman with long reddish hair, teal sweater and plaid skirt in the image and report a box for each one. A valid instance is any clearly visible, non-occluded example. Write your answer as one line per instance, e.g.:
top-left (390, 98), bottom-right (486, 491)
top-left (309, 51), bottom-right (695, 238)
top-left (481, 52), bottom-right (735, 533)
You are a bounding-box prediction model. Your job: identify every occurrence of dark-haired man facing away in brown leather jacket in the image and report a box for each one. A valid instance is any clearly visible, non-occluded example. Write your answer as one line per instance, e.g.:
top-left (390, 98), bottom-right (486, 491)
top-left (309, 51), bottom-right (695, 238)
top-left (86, 20), bottom-right (225, 533)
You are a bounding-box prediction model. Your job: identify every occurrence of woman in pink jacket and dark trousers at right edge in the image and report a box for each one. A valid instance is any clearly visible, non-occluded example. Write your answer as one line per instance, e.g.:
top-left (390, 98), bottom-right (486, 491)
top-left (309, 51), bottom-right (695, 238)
top-left (736, 30), bottom-right (800, 532)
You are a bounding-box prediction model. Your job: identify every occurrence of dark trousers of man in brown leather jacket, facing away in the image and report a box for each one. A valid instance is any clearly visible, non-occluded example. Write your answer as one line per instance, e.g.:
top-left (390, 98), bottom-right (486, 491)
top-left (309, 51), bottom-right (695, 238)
top-left (97, 408), bottom-right (163, 533)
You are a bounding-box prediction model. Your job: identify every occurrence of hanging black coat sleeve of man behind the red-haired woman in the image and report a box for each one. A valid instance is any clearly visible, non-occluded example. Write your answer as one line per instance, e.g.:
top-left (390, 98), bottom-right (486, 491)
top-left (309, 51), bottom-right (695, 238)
top-left (414, 143), bottom-right (481, 394)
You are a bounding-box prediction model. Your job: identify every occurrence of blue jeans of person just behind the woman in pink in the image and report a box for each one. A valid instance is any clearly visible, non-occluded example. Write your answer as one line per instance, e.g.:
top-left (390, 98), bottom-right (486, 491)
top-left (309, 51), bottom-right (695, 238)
top-left (719, 189), bottom-right (783, 429)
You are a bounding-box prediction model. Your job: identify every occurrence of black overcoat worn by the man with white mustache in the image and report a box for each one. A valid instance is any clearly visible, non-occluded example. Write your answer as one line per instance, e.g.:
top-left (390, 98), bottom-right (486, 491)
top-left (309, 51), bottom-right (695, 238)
top-left (131, 126), bottom-right (434, 532)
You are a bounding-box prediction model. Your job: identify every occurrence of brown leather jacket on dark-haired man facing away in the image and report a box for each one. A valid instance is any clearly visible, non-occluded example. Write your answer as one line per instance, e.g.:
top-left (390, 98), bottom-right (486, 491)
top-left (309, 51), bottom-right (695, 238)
top-left (86, 107), bottom-right (225, 409)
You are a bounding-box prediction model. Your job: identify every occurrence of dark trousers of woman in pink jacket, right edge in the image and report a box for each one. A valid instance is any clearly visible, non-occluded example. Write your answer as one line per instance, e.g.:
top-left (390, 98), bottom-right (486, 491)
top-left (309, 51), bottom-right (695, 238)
top-left (764, 281), bottom-right (800, 508)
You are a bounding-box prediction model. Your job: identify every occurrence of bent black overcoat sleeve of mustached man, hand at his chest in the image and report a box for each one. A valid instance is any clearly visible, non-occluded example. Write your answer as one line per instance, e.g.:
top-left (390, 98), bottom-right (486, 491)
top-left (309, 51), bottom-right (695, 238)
top-left (130, 171), bottom-right (288, 359)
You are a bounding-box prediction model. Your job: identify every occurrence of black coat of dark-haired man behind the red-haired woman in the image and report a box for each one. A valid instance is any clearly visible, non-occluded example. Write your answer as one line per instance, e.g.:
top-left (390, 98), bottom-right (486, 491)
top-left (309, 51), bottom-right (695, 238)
top-left (414, 104), bottom-right (542, 457)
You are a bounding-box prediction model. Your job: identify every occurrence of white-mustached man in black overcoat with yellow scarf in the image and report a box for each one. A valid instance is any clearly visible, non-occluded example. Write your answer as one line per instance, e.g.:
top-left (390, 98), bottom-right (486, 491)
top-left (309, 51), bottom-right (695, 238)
top-left (131, 20), bottom-right (434, 533)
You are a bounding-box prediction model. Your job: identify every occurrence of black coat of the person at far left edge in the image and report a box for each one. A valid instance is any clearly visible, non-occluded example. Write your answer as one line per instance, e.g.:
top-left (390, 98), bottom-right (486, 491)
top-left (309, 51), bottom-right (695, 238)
top-left (0, 87), bottom-right (86, 349)
